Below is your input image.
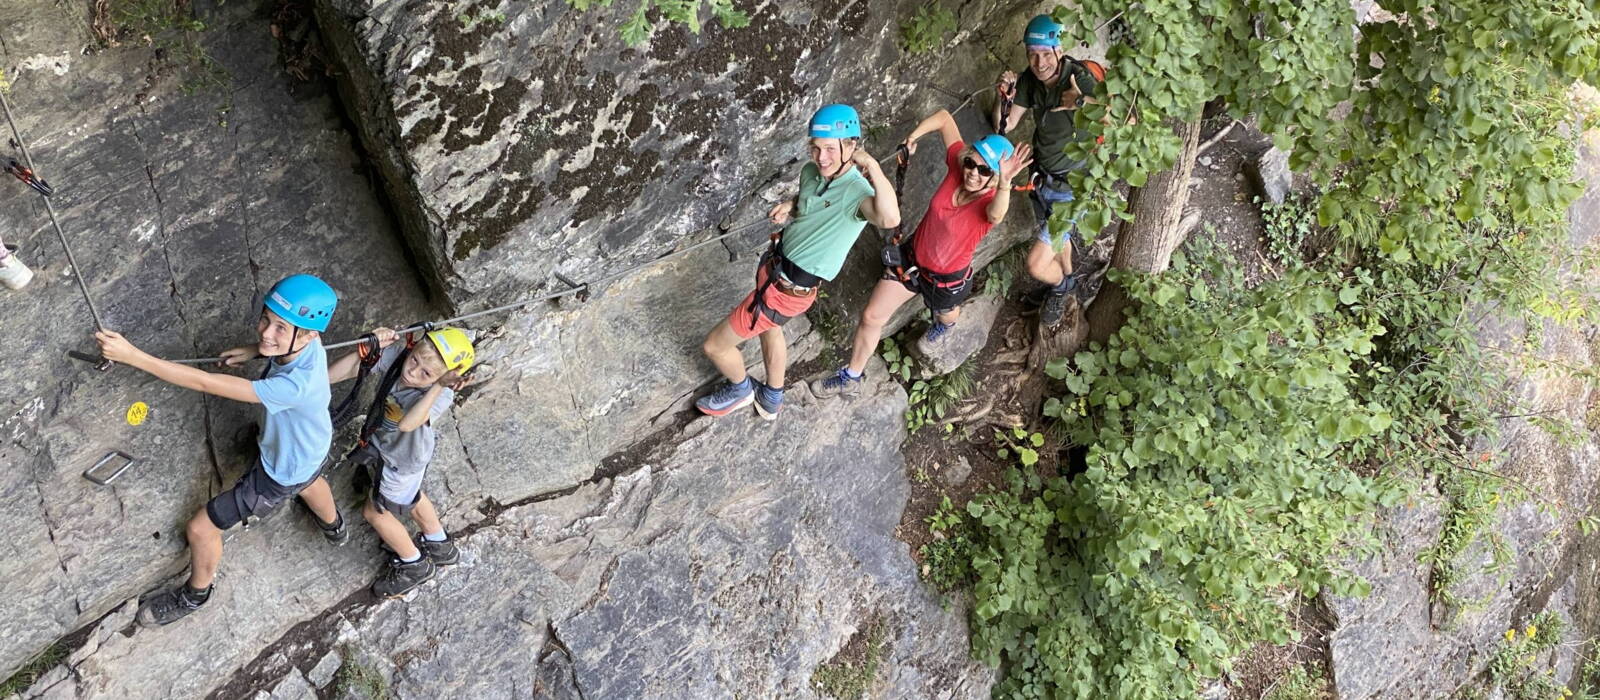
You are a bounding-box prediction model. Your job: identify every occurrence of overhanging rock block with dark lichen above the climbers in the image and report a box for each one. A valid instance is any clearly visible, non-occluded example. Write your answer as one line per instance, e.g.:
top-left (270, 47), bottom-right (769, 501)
top-left (317, 0), bottom-right (1030, 305)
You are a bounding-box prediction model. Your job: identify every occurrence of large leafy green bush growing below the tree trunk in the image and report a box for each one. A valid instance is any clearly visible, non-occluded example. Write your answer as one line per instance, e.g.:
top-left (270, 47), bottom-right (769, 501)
top-left (968, 242), bottom-right (1402, 698)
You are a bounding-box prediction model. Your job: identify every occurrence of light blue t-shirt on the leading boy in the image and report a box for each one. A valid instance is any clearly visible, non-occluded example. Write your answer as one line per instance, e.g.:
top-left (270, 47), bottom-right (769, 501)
top-left (250, 340), bottom-right (333, 486)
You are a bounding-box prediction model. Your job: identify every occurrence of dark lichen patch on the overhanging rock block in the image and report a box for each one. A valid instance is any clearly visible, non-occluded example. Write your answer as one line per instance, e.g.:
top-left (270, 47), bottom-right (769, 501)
top-left (397, 0), bottom-right (889, 262)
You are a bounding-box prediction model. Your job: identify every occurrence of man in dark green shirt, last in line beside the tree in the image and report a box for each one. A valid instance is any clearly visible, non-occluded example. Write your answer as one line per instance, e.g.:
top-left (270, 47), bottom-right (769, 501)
top-left (994, 14), bottom-right (1099, 326)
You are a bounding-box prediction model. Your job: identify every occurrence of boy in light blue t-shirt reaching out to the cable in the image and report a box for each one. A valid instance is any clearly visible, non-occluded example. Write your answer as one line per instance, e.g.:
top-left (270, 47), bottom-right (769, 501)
top-left (94, 275), bottom-right (350, 626)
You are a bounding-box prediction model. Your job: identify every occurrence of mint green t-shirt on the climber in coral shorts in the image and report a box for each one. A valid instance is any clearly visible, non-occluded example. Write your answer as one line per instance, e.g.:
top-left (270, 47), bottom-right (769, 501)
top-left (782, 163), bottom-right (872, 281)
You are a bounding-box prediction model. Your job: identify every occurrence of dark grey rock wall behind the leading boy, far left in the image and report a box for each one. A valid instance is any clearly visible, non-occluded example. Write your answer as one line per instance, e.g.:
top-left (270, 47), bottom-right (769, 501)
top-left (0, 2), bottom-right (429, 676)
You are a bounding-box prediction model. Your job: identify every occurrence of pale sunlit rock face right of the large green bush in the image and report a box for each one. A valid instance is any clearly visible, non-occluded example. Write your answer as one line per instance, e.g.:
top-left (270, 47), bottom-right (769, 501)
top-left (1325, 134), bottom-right (1600, 700)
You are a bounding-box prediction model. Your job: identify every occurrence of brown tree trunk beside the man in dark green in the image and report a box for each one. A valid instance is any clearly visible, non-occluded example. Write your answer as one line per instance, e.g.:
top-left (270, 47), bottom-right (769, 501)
top-left (1088, 118), bottom-right (1200, 342)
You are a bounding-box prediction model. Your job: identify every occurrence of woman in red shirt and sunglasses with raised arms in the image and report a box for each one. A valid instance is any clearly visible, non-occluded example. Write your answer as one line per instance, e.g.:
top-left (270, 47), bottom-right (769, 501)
top-left (811, 109), bottom-right (1032, 398)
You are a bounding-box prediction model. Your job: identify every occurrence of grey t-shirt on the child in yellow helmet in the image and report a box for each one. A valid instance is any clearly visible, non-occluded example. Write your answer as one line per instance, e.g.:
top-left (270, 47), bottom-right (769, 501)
top-left (373, 344), bottom-right (456, 503)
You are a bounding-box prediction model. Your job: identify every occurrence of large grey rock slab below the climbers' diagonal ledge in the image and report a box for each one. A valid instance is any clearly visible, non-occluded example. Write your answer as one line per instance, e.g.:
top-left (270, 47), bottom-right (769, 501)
top-left (43, 366), bottom-right (992, 698)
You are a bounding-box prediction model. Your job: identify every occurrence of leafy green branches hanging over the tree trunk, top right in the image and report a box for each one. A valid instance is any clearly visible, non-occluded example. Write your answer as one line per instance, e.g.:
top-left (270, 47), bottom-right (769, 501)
top-left (1054, 0), bottom-right (1600, 255)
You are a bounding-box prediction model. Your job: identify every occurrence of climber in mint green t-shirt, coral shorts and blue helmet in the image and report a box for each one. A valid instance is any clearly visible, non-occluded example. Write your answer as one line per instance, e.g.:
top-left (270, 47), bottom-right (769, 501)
top-left (694, 104), bottom-right (899, 420)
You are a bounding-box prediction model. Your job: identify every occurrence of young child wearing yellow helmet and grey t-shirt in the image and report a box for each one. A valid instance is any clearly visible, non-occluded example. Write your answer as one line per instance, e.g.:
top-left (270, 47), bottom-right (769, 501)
top-left (328, 328), bottom-right (477, 598)
